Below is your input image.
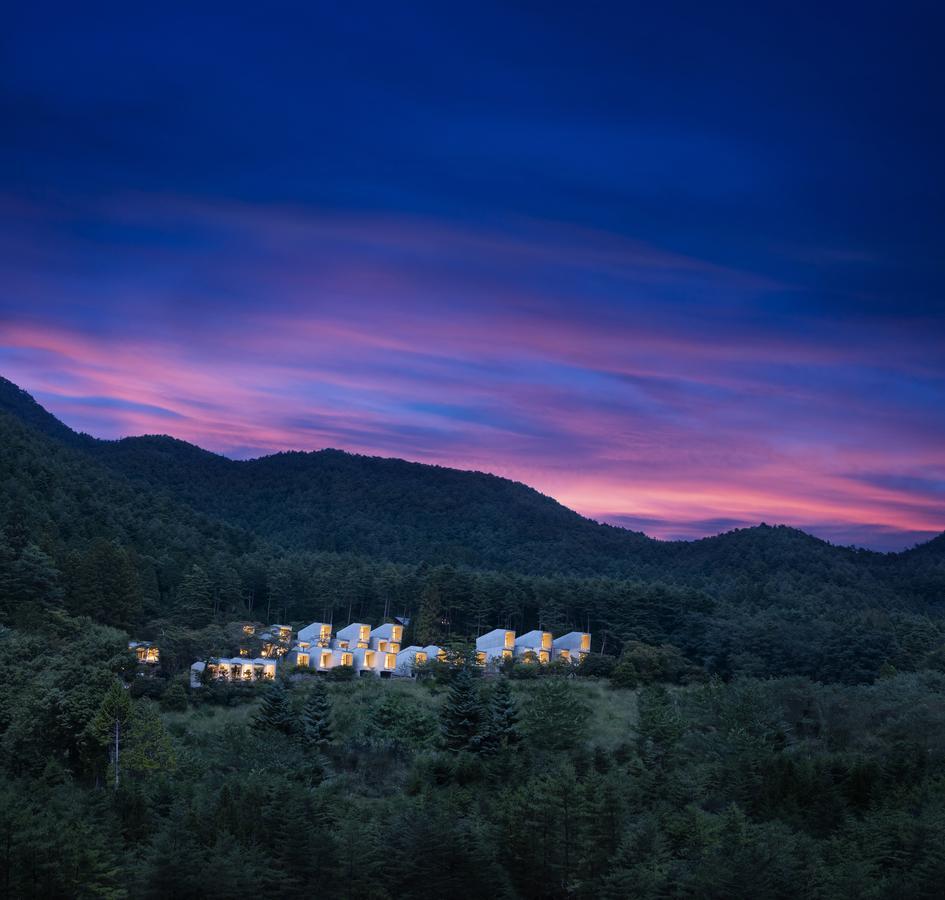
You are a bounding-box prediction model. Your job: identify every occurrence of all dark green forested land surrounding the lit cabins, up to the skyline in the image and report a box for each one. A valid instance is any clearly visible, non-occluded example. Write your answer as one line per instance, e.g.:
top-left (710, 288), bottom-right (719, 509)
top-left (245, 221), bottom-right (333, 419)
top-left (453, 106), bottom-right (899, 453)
top-left (0, 382), bottom-right (945, 898)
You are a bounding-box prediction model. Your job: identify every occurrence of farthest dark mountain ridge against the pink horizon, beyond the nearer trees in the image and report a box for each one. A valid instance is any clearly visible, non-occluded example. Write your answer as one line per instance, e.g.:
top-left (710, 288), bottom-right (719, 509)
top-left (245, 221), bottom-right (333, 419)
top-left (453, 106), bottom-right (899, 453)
top-left (0, 379), bottom-right (945, 605)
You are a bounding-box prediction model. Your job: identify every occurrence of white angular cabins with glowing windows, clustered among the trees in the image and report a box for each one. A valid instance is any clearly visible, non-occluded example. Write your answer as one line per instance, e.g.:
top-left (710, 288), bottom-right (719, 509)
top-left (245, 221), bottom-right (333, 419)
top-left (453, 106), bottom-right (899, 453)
top-left (191, 622), bottom-right (591, 687)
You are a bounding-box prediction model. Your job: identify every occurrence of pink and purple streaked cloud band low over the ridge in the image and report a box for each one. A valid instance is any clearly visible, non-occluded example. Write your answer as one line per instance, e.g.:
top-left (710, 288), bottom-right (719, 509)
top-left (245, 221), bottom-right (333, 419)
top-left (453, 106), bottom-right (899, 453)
top-left (0, 195), bottom-right (945, 548)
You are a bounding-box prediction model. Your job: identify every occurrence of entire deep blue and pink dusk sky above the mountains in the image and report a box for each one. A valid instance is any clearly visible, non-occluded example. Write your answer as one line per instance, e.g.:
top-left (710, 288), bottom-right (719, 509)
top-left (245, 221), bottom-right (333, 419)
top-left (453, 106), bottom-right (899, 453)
top-left (0, 0), bottom-right (945, 550)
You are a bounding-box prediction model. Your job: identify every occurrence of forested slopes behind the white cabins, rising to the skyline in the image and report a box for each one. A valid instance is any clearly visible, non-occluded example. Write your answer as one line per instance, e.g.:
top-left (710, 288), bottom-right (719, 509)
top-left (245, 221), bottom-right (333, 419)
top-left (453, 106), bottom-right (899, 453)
top-left (0, 382), bottom-right (945, 681)
